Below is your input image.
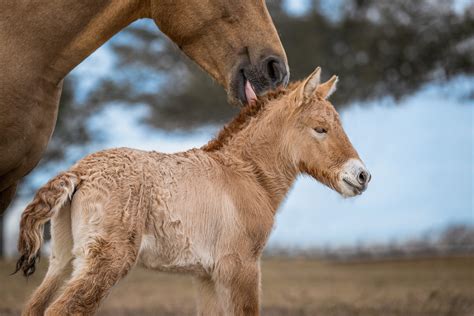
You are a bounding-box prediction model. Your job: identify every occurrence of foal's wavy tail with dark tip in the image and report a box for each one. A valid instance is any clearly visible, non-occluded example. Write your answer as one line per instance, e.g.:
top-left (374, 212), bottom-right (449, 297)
top-left (14, 172), bottom-right (80, 276)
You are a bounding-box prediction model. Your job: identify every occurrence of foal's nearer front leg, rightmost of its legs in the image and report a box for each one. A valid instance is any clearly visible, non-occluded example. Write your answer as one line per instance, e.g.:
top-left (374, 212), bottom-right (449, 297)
top-left (214, 255), bottom-right (260, 316)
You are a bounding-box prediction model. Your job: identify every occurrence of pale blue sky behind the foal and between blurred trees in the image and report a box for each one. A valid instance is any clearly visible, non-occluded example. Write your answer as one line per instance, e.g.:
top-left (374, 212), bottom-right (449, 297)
top-left (1, 1), bottom-right (474, 253)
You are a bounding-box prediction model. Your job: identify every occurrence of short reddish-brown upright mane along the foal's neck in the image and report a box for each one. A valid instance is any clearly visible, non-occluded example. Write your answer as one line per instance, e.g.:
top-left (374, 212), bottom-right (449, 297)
top-left (201, 83), bottom-right (295, 152)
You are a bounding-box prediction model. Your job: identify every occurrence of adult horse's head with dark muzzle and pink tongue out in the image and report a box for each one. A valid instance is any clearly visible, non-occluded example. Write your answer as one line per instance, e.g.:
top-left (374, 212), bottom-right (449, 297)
top-left (148, 0), bottom-right (289, 104)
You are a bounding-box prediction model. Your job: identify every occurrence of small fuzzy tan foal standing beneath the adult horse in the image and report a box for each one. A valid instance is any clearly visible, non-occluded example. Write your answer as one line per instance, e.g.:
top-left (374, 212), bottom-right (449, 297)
top-left (17, 68), bottom-right (370, 315)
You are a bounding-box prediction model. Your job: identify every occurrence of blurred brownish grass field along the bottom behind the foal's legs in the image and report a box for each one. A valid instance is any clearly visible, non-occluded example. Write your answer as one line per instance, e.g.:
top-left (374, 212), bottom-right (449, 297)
top-left (0, 257), bottom-right (474, 316)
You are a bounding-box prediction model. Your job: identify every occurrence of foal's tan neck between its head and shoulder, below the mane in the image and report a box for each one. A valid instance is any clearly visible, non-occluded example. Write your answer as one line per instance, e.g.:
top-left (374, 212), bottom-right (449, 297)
top-left (221, 100), bottom-right (298, 211)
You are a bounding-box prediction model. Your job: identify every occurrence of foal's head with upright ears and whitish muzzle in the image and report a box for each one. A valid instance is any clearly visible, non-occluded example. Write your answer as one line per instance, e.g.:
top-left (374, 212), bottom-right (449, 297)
top-left (284, 67), bottom-right (371, 196)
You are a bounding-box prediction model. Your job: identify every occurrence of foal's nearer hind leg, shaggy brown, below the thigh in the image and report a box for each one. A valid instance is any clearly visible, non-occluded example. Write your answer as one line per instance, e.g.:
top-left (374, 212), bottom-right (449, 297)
top-left (46, 237), bottom-right (138, 315)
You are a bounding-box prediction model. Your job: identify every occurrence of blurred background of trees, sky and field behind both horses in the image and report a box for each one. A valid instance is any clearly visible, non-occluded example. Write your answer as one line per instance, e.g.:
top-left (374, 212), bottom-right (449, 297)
top-left (0, 0), bottom-right (474, 315)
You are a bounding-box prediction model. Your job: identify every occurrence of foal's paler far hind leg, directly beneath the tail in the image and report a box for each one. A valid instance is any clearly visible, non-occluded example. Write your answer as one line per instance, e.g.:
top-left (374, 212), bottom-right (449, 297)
top-left (23, 204), bottom-right (72, 316)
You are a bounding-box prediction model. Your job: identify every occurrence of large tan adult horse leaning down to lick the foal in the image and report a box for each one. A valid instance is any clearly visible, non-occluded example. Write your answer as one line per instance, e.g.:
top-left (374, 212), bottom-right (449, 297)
top-left (0, 0), bottom-right (288, 252)
